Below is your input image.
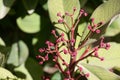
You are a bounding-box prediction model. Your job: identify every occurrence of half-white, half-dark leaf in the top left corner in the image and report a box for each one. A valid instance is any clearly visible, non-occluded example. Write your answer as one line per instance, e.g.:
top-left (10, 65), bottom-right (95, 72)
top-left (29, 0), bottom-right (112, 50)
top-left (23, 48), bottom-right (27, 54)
top-left (0, 0), bottom-right (15, 19)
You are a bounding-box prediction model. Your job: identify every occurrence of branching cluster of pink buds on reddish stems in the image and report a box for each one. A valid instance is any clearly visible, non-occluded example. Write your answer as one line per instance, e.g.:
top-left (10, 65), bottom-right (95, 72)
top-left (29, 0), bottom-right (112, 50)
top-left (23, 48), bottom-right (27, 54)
top-left (36, 7), bottom-right (110, 80)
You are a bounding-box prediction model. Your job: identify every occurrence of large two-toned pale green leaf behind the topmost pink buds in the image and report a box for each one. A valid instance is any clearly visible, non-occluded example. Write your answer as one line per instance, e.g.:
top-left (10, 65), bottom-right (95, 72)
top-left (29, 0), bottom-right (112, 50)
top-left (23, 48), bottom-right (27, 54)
top-left (48, 0), bottom-right (80, 32)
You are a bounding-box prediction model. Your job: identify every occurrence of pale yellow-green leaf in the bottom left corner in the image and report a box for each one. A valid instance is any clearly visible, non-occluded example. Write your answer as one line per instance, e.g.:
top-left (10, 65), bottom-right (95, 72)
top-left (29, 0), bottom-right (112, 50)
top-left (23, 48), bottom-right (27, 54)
top-left (0, 67), bottom-right (15, 80)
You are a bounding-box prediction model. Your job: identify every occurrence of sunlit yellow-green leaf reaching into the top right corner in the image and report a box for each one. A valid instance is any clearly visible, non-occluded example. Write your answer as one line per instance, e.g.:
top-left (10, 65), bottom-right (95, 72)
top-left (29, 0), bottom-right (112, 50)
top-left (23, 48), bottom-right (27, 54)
top-left (91, 0), bottom-right (120, 23)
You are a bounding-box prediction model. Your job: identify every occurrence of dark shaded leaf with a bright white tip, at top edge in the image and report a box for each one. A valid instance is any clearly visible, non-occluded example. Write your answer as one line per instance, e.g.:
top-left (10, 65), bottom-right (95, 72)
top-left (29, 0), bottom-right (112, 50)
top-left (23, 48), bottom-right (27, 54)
top-left (22, 0), bottom-right (38, 14)
